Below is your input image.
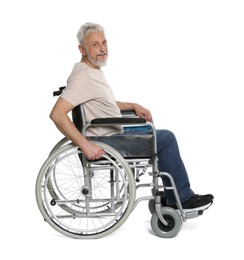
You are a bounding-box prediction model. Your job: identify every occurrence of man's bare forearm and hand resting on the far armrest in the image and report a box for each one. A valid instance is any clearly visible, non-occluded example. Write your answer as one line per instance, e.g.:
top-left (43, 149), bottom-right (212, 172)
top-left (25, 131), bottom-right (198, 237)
top-left (116, 101), bottom-right (152, 122)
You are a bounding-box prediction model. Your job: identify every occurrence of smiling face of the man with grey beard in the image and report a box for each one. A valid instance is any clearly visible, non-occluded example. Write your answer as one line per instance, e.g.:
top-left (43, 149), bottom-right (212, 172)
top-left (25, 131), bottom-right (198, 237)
top-left (80, 32), bottom-right (108, 68)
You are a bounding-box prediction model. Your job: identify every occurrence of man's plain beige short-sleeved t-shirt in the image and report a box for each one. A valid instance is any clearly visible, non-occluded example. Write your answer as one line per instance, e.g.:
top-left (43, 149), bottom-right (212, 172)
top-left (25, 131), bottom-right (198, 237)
top-left (61, 62), bottom-right (122, 136)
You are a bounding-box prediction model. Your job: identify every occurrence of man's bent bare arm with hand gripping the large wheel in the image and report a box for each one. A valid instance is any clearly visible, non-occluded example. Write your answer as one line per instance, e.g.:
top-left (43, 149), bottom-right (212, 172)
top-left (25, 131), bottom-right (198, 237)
top-left (50, 97), bottom-right (104, 160)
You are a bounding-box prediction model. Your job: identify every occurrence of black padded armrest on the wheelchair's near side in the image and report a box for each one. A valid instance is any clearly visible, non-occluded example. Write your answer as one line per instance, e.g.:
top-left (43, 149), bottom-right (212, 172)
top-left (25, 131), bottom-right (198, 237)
top-left (91, 117), bottom-right (147, 125)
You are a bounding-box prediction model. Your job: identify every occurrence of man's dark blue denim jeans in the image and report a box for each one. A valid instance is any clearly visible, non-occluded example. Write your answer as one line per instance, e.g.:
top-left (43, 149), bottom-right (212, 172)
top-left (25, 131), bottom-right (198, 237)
top-left (121, 127), bottom-right (194, 205)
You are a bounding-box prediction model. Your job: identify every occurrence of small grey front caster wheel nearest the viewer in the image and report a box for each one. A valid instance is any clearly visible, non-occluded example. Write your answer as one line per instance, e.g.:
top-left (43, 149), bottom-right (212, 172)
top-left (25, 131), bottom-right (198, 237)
top-left (151, 207), bottom-right (182, 238)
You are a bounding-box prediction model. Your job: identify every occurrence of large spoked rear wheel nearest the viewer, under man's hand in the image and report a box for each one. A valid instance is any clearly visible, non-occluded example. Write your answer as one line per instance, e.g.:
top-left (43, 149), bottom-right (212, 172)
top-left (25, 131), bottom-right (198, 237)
top-left (36, 142), bottom-right (135, 238)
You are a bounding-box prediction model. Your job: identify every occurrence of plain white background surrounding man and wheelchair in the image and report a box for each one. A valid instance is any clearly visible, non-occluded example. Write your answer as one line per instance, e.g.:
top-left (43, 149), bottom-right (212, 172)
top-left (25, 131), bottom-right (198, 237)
top-left (0, 0), bottom-right (244, 260)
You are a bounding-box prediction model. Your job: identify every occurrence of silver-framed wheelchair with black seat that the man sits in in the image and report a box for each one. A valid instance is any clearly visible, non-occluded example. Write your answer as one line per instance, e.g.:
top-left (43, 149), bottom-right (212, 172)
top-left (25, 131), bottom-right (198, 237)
top-left (35, 87), bottom-right (201, 239)
